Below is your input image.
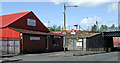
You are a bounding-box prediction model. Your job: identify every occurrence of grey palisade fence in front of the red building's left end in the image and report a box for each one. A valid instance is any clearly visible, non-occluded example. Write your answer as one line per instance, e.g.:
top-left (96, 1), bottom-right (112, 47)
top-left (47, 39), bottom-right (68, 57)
top-left (0, 37), bottom-right (20, 55)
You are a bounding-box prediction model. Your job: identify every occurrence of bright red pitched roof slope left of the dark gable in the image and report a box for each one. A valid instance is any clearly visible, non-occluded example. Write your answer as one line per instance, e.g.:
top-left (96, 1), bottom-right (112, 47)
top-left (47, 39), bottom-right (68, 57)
top-left (0, 11), bottom-right (32, 27)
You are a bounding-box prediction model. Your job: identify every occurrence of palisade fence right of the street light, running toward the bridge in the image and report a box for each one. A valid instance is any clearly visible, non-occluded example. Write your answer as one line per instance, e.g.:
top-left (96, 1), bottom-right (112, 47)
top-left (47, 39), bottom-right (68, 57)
top-left (66, 38), bottom-right (115, 52)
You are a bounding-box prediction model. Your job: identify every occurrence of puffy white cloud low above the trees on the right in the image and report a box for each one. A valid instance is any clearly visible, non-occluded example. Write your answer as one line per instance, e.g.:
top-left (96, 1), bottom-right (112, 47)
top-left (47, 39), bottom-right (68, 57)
top-left (80, 16), bottom-right (103, 26)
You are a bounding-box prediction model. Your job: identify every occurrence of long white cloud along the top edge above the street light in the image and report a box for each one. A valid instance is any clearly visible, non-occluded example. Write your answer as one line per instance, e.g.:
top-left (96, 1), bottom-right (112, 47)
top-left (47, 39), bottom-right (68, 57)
top-left (50, 0), bottom-right (119, 7)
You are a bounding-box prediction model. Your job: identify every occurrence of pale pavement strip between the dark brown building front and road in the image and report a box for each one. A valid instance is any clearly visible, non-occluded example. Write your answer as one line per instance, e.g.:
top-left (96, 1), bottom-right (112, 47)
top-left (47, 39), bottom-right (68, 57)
top-left (16, 51), bottom-right (105, 57)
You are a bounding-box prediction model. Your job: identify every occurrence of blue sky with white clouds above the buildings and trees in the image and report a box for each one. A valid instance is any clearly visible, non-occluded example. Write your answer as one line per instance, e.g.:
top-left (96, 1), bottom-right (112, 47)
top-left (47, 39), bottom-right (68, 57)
top-left (2, 0), bottom-right (118, 29)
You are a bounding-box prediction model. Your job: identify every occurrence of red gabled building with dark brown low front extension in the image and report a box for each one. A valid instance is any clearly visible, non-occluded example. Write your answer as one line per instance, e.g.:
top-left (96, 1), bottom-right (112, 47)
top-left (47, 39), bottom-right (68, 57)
top-left (0, 11), bottom-right (63, 53)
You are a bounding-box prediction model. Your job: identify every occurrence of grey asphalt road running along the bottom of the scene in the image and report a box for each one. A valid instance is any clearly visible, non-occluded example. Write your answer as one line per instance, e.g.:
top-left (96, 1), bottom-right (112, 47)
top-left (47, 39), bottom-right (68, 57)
top-left (3, 52), bottom-right (120, 61)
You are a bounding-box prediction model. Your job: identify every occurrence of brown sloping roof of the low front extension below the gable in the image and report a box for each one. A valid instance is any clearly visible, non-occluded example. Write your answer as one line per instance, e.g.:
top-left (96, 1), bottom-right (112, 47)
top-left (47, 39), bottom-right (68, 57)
top-left (8, 27), bottom-right (58, 35)
